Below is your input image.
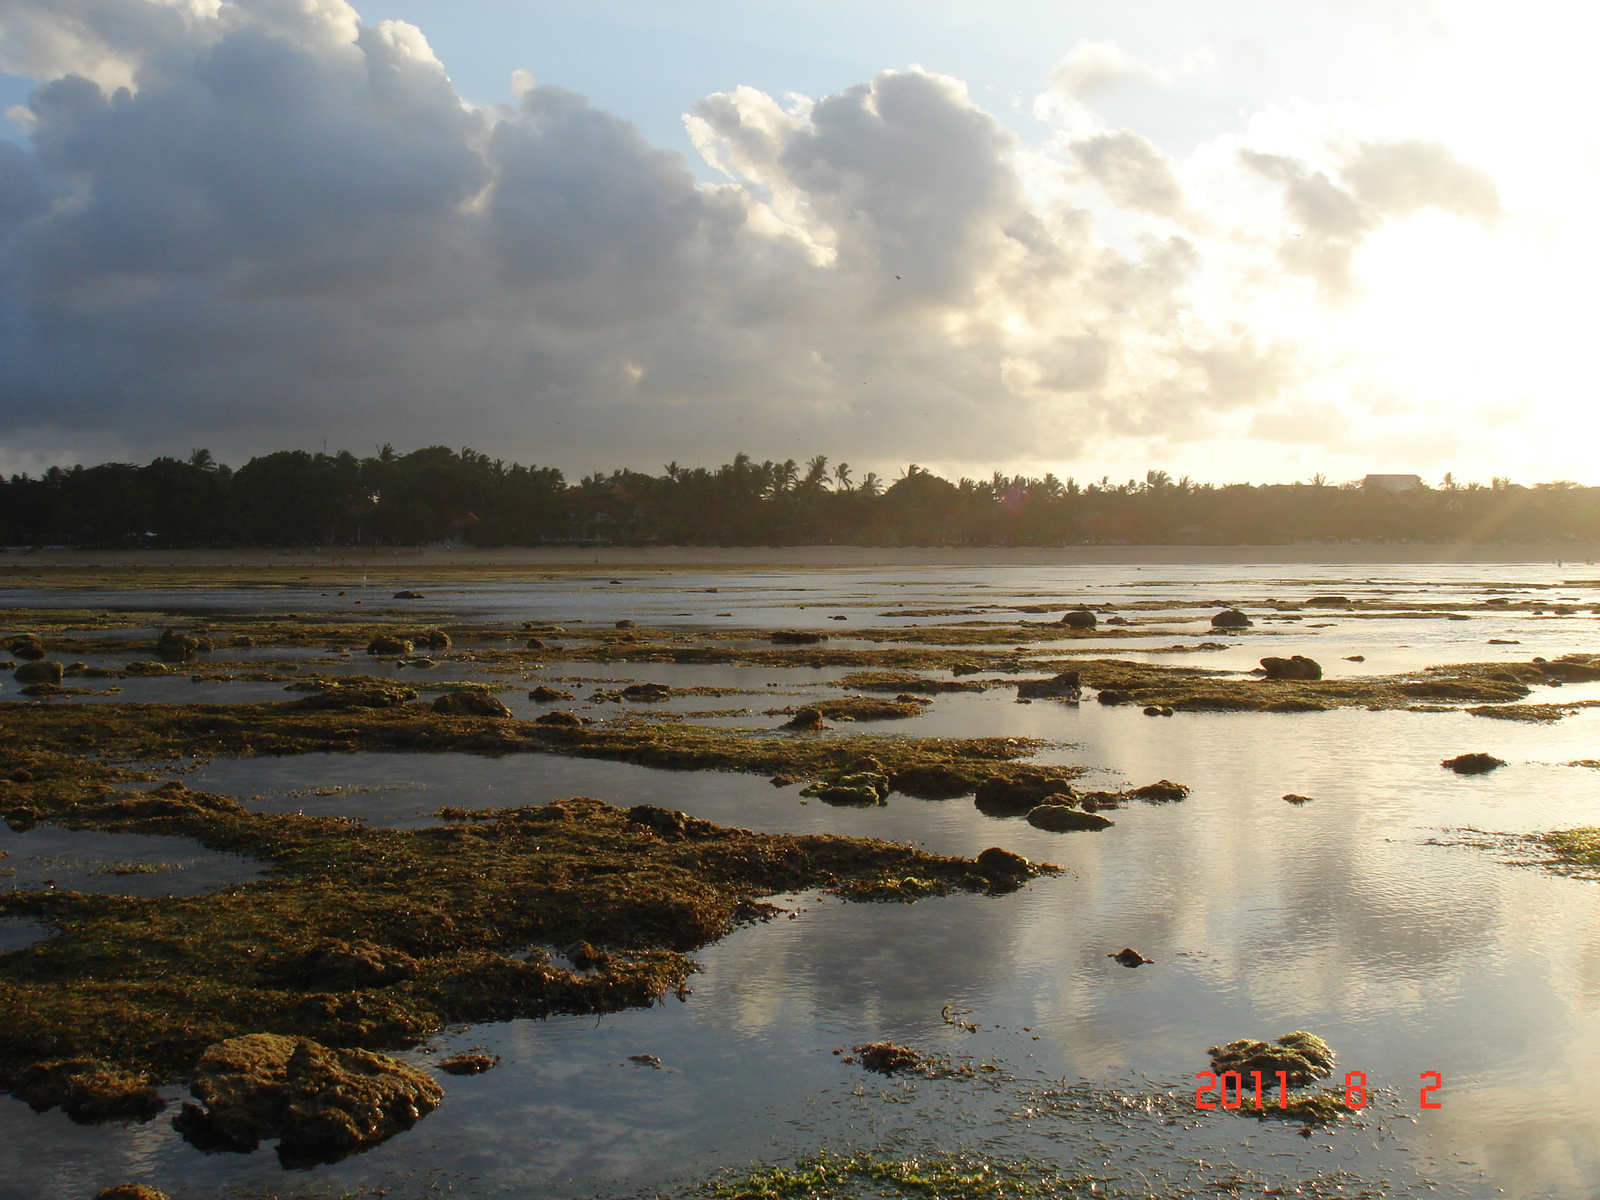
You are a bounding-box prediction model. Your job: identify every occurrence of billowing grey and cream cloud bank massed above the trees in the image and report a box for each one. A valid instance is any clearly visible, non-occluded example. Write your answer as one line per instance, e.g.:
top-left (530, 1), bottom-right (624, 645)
top-left (0, 0), bottom-right (1493, 470)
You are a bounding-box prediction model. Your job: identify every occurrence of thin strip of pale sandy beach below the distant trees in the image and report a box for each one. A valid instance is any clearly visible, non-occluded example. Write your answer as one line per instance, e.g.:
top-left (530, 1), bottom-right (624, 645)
top-left (0, 542), bottom-right (1600, 581)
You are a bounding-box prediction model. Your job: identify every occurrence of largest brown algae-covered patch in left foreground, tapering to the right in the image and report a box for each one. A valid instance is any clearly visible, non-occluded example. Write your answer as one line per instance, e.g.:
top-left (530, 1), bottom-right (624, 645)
top-left (0, 784), bottom-right (1056, 1107)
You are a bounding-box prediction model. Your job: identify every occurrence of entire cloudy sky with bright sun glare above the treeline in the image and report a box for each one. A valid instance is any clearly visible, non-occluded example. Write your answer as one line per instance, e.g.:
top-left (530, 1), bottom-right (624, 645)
top-left (0, 0), bottom-right (1600, 483)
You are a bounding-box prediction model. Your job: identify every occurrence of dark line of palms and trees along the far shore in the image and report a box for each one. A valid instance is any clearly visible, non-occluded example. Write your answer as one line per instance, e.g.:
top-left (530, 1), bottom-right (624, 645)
top-left (0, 446), bottom-right (1600, 549)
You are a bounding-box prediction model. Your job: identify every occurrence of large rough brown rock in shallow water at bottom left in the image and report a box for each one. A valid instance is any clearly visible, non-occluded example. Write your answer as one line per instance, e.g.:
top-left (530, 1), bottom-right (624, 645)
top-left (173, 1034), bottom-right (445, 1166)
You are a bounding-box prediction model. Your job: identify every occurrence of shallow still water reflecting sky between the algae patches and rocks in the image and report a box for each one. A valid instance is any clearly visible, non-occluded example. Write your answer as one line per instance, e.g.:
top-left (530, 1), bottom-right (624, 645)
top-left (0, 566), bottom-right (1600, 1200)
